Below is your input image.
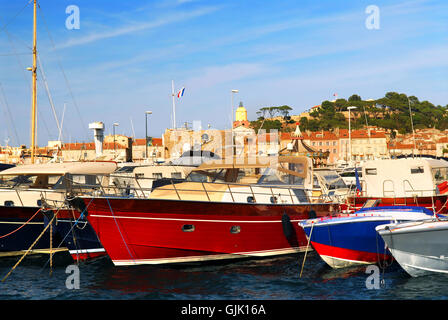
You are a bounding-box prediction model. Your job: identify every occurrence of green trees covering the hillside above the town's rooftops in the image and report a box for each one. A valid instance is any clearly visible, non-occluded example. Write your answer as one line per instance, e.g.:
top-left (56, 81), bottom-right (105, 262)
top-left (250, 91), bottom-right (448, 133)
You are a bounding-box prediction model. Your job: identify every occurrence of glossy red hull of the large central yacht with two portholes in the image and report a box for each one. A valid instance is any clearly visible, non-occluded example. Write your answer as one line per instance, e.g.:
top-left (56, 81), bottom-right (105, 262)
top-left (84, 198), bottom-right (335, 265)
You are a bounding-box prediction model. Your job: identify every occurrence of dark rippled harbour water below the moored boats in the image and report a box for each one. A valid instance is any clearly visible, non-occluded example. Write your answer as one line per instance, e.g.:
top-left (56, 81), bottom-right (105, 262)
top-left (0, 253), bottom-right (448, 300)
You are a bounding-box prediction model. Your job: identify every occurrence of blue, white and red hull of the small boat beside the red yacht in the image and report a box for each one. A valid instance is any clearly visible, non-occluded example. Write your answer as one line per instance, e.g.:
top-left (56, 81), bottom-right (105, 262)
top-left (299, 206), bottom-right (433, 268)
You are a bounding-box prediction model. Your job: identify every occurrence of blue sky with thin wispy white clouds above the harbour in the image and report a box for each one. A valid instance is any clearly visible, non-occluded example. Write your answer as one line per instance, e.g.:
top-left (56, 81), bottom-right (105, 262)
top-left (0, 0), bottom-right (448, 146)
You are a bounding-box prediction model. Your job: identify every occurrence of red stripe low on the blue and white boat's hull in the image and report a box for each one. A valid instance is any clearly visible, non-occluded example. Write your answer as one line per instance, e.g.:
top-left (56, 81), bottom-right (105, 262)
top-left (311, 241), bottom-right (392, 264)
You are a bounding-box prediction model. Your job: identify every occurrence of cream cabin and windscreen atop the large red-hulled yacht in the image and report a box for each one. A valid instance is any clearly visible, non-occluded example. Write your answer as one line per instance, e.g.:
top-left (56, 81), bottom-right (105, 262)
top-left (149, 156), bottom-right (313, 204)
